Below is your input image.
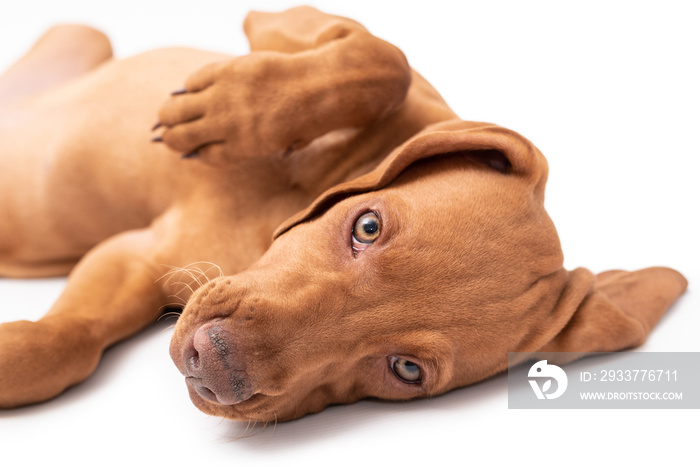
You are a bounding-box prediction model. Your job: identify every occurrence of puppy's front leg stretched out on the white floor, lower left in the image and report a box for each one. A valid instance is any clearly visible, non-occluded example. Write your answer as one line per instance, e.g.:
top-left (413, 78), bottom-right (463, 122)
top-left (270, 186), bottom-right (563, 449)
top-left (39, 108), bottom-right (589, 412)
top-left (0, 229), bottom-right (167, 408)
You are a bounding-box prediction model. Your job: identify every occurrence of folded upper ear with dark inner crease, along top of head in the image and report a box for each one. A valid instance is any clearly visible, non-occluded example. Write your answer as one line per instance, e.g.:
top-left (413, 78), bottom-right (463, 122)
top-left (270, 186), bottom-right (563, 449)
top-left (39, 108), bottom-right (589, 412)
top-left (273, 120), bottom-right (548, 238)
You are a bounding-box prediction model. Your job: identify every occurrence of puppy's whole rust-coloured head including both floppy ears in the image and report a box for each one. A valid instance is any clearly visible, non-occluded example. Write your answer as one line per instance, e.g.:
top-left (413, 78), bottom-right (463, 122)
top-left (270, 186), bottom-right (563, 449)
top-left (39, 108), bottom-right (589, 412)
top-left (171, 122), bottom-right (685, 420)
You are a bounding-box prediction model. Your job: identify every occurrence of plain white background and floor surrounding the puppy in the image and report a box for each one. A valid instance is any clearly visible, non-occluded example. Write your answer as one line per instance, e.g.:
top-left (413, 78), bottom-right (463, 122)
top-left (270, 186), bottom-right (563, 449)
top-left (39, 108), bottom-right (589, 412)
top-left (0, 0), bottom-right (700, 466)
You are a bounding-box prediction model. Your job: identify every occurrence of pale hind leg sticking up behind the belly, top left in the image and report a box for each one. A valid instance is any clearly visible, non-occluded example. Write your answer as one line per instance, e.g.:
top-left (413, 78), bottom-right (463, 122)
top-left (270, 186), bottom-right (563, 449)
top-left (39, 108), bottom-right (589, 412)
top-left (0, 25), bottom-right (112, 110)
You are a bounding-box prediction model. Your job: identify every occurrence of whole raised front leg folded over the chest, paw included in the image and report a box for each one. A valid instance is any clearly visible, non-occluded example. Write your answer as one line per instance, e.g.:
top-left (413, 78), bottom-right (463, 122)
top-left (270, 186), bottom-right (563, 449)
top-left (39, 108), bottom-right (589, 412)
top-left (159, 7), bottom-right (411, 163)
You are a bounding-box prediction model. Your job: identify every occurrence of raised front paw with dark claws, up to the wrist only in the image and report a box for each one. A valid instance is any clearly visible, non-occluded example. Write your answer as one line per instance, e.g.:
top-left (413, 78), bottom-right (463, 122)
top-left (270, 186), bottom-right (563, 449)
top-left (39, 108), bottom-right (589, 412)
top-left (154, 52), bottom-right (298, 165)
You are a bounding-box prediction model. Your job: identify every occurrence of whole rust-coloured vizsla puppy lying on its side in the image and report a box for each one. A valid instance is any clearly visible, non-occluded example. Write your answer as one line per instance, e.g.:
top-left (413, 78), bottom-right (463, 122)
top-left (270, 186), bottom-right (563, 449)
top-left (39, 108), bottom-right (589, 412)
top-left (0, 7), bottom-right (686, 421)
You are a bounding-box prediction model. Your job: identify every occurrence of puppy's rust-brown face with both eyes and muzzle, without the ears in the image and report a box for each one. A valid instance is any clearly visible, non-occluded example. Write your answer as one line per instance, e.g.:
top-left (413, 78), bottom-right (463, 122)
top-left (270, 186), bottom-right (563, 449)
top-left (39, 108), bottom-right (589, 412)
top-left (171, 122), bottom-right (562, 420)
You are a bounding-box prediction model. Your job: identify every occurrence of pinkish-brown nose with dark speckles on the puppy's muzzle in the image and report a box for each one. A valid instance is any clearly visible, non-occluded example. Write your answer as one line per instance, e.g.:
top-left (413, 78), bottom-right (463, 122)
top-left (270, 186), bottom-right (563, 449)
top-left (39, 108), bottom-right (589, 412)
top-left (184, 321), bottom-right (253, 405)
